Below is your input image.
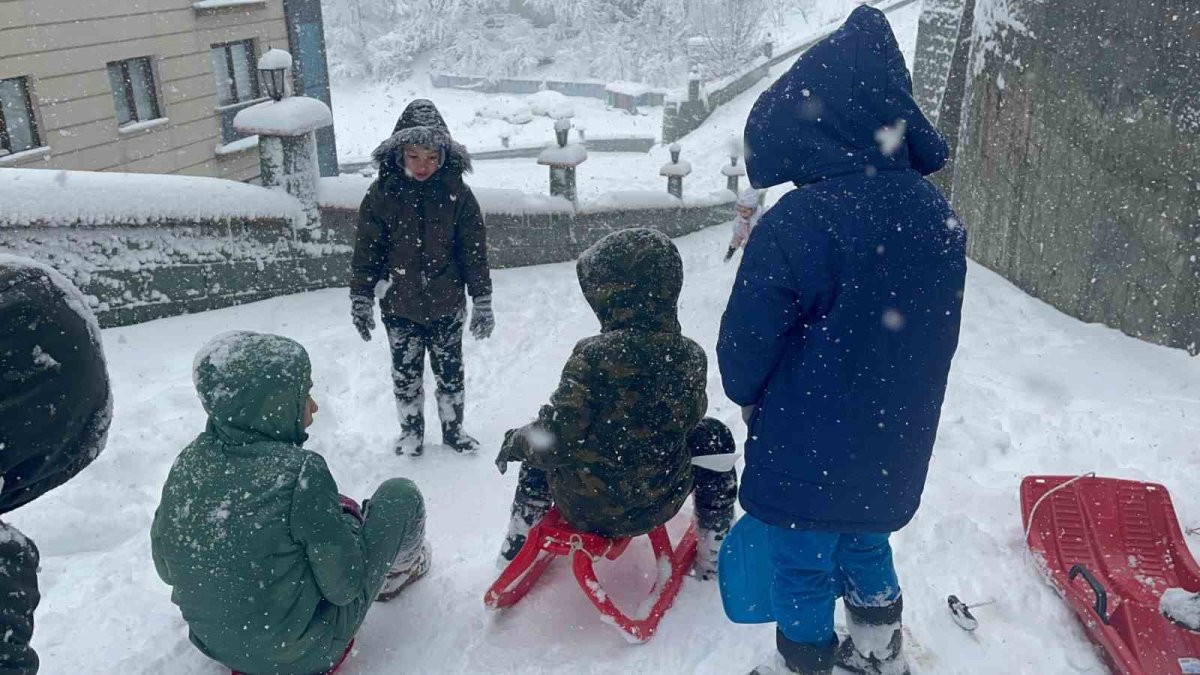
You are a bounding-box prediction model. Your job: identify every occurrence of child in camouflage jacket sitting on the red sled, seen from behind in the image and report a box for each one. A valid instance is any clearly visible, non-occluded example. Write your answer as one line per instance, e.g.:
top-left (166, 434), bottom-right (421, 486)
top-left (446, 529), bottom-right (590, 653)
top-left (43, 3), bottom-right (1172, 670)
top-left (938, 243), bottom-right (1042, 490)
top-left (497, 229), bottom-right (737, 575)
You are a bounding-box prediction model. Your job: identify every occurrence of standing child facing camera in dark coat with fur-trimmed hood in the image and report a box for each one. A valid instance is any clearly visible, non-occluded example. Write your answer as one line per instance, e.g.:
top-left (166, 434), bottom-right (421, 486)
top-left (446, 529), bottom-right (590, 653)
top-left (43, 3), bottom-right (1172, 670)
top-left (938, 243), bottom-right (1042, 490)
top-left (350, 100), bottom-right (496, 455)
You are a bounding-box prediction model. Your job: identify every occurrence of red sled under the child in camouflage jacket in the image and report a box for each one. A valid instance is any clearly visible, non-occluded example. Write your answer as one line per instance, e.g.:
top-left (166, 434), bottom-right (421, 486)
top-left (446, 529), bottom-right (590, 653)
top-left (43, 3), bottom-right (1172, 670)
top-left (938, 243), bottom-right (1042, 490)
top-left (484, 508), bottom-right (696, 643)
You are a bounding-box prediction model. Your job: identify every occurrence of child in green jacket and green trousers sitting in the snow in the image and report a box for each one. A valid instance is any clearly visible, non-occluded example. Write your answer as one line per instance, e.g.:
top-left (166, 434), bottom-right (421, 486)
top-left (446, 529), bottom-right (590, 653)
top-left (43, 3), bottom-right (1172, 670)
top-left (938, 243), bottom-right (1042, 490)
top-left (150, 333), bottom-right (430, 675)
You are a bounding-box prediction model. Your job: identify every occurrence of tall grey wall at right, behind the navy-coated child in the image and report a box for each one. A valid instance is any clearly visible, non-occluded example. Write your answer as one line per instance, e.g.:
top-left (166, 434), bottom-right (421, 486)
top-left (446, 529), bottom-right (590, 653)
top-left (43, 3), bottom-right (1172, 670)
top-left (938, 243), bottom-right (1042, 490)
top-left (940, 0), bottom-right (1200, 353)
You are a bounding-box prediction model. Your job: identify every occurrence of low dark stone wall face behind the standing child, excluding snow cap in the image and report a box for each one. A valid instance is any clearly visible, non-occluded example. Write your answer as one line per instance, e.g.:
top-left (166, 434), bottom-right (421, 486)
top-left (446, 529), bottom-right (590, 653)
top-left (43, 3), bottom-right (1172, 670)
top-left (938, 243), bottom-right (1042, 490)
top-left (0, 196), bottom-right (732, 327)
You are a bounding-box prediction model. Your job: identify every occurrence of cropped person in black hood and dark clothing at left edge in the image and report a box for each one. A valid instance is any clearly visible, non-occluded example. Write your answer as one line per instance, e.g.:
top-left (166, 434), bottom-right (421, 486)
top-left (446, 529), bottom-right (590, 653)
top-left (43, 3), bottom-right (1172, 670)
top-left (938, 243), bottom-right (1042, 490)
top-left (0, 255), bottom-right (113, 675)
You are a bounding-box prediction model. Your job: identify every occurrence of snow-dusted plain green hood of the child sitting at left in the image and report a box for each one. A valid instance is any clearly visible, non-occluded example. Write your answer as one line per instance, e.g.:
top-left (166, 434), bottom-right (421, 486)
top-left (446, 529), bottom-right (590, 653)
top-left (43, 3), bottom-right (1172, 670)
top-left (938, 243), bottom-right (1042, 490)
top-left (192, 331), bottom-right (312, 446)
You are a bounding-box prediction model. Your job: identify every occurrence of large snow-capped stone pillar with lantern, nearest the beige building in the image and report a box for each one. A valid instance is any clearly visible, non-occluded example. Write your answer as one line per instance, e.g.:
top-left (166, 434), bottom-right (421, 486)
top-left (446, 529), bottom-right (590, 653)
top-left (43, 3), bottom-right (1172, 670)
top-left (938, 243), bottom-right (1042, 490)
top-left (233, 49), bottom-right (334, 235)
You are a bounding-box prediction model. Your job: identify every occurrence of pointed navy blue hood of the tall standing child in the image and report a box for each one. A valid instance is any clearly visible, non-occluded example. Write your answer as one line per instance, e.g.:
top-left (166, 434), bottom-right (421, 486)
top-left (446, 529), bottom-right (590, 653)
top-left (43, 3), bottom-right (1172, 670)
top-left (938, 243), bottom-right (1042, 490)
top-left (745, 6), bottom-right (948, 189)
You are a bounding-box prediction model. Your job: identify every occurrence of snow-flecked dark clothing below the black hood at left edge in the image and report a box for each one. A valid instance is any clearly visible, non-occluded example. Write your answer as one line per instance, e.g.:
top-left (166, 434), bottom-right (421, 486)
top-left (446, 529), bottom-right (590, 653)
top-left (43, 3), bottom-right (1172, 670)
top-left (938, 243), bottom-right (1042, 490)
top-left (0, 522), bottom-right (41, 675)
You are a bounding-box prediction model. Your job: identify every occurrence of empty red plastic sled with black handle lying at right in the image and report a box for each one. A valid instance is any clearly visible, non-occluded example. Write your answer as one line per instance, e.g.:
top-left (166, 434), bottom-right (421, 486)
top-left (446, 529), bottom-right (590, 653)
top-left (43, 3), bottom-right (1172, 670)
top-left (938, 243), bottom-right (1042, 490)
top-left (1021, 476), bottom-right (1200, 675)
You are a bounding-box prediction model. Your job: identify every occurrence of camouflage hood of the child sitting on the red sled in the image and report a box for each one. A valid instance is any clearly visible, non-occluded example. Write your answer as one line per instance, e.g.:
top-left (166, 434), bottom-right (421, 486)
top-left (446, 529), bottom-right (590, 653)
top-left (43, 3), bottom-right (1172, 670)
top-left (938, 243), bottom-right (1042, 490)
top-left (576, 228), bottom-right (683, 333)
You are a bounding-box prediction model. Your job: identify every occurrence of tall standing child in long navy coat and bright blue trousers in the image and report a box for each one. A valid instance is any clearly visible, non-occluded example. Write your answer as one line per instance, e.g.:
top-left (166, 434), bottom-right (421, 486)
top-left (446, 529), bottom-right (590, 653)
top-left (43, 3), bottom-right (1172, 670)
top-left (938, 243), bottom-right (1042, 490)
top-left (718, 7), bottom-right (966, 674)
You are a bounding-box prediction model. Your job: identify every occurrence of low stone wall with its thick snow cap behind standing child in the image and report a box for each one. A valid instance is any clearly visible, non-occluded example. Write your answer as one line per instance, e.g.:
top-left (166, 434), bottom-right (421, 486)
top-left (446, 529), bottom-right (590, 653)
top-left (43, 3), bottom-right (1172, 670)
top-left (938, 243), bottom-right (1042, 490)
top-left (0, 169), bottom-right (734, 327)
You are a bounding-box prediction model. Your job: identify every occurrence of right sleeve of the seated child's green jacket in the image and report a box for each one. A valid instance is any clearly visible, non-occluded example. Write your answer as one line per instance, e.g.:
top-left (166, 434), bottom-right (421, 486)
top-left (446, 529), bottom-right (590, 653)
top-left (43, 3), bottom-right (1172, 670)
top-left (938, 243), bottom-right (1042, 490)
top-left (292, 453), bottom-right (366, 605)
